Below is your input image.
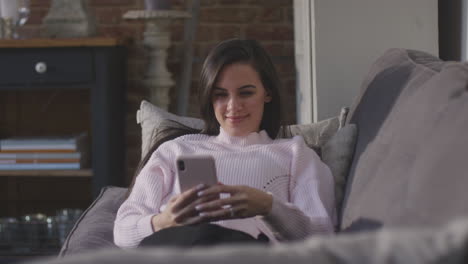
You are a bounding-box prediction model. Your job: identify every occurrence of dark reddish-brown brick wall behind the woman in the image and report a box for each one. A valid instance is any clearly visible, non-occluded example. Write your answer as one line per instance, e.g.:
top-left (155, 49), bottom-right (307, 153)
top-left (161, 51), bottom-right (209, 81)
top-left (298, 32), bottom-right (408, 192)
top-left (21, 0), bottom-right (296, 183)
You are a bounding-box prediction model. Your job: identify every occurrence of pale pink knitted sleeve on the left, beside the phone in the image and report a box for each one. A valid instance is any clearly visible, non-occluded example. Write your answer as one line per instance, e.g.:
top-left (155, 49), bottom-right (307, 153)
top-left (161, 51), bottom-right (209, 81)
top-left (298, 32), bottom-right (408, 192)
top-left (114, 153), bottom-right (174, 248)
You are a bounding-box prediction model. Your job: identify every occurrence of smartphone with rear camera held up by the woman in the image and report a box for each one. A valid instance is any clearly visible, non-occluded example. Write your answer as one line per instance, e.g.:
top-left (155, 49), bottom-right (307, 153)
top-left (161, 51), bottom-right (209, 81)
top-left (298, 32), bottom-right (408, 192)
top-left (176, 155), bottom-right (218, 192)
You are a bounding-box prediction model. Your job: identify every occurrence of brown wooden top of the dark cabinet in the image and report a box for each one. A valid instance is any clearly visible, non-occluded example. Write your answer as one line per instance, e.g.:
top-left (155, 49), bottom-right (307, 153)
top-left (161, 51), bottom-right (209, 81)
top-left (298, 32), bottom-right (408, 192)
top-left (0, 37), bottom-right (129, 48)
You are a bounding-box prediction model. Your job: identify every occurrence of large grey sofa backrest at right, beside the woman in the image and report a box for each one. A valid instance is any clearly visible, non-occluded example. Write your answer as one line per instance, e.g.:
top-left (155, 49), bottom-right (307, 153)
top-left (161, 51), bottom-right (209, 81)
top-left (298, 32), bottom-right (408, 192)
top-left (341, 49), bottom-right (468, 230)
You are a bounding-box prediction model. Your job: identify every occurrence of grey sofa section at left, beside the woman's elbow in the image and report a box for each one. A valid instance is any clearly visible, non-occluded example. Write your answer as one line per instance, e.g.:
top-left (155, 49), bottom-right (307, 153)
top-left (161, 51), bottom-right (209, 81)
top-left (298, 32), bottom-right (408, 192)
top-left (59, 186), bottom-right (127, 257)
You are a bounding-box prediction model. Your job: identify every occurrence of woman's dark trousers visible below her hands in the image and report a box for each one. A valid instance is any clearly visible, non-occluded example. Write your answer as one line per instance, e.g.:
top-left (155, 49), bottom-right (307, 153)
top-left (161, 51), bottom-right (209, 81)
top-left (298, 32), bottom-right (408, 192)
top-left (139, 224), bottom-right (269, 247)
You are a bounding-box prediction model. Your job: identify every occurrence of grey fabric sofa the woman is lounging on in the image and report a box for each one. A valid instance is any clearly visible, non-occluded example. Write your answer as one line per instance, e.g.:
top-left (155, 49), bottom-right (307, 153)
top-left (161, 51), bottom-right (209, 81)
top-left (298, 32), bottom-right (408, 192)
top-left (28, 49), bottom-right (468, 264)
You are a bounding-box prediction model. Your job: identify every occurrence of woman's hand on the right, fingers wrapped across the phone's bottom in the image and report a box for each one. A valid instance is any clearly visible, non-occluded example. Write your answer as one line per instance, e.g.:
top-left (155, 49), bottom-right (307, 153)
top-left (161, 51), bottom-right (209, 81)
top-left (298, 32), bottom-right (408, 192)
top-left (195, 184), bottom-right (273, 222)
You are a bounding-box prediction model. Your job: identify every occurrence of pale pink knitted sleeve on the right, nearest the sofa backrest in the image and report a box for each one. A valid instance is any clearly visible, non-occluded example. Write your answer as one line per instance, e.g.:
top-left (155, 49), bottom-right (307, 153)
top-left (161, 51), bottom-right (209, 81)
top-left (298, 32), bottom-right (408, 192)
top-left (263, 137), bottom-right (335, 240)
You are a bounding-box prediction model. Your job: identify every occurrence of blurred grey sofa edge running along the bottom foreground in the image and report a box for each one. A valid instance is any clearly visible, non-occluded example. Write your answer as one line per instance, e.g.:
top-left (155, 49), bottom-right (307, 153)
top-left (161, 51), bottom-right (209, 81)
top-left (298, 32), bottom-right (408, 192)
top-left (35, 219), bottom-right (468, 264)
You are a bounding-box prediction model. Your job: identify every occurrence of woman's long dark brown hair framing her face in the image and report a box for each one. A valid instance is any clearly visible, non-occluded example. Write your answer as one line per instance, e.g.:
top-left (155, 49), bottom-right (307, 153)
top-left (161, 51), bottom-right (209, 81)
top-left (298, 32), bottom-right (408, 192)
top-left (127, 39), bottom-right (282, 196)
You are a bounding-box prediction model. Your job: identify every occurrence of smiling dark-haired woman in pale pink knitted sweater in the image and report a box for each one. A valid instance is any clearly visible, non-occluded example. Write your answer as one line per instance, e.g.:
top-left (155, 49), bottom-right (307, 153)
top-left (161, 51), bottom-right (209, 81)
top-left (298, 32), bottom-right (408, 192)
top-left (114, 39), bottom-right (335, 248)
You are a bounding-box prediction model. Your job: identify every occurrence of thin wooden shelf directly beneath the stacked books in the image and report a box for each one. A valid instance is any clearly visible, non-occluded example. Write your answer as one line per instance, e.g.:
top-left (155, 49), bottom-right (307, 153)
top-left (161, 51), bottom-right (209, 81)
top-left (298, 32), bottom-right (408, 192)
top-left (0, 169), bottom-right (93, 177)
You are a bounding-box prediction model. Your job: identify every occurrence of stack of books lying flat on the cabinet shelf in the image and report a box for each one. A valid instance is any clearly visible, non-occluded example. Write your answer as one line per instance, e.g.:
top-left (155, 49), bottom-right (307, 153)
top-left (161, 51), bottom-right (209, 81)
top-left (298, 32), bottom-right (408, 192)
top-left (0, 134), bottom-right (89, 170)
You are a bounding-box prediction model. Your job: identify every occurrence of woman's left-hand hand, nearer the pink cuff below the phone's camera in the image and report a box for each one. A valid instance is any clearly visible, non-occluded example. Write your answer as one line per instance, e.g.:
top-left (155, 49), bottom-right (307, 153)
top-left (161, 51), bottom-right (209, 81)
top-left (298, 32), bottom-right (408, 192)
top-left (151, 184), bottom-right (218, 232)
